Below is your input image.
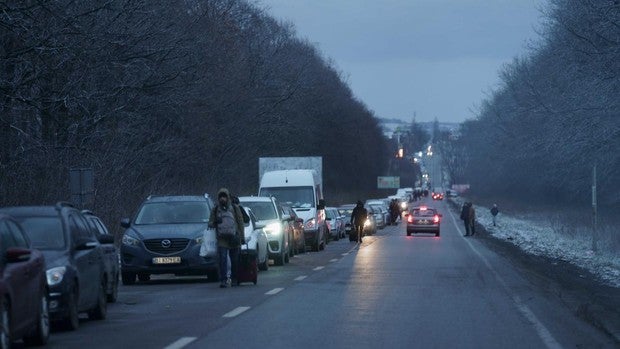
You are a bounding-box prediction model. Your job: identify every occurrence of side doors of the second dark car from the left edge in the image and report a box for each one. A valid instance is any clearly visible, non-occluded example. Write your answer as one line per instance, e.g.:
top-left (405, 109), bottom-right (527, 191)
top-left (68, 213), bottom-right (101, 310)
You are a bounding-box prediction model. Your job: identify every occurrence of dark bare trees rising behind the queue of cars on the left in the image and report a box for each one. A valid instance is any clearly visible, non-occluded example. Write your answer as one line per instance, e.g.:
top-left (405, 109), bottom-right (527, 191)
top-left (0, 0), bottom-right (388, 231)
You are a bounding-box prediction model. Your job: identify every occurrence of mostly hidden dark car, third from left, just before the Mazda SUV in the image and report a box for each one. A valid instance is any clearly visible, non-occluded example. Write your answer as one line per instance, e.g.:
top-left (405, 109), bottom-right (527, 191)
top-left (82, 210), bottom-right (120, 303)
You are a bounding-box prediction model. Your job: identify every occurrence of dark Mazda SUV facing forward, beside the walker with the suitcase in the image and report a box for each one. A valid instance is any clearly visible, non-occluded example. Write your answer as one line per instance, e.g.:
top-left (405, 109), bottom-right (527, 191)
top-left (121, 194), bottom-right (218, 285)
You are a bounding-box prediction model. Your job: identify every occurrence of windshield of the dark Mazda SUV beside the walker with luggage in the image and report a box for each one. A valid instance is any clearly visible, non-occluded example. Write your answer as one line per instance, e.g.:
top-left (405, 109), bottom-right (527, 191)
top-left (135, 201), bottom-right (211, 224)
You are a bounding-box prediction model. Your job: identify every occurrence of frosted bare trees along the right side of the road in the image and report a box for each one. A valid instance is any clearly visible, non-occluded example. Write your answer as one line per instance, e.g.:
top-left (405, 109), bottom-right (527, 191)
top-left (443, 0), bottom-right (620, 209)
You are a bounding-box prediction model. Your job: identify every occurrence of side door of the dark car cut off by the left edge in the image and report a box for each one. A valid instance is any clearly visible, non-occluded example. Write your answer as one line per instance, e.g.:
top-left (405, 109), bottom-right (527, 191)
top-left (0, 220), bottom-right (39, 331)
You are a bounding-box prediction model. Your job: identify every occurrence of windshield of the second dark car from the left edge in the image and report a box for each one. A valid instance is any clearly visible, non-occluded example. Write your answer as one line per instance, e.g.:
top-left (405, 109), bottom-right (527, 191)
top-left (17, 217), bottom-right (67, 250)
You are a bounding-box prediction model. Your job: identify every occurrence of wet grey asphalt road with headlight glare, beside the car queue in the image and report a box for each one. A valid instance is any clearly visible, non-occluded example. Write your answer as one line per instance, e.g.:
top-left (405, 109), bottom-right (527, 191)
top-left (40, 197), bottom-right (618, 349)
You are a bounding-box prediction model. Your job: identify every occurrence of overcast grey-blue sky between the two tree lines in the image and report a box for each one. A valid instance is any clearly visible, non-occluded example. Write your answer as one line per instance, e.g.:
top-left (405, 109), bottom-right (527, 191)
top-left (260, 0), bottom-right (544, 122)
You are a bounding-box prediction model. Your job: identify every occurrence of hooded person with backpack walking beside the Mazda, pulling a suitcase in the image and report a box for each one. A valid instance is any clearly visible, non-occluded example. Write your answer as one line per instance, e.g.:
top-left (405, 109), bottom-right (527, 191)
top-left (209, 188), bottom-right (244, 288)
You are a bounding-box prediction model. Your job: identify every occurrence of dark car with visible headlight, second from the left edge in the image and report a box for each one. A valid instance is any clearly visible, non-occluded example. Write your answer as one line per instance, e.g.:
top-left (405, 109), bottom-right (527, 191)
top-left (0, 203), bottom-right (108, 330)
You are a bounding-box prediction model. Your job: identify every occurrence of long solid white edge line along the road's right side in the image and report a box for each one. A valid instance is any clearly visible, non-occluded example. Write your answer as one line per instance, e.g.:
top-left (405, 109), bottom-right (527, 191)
top-left (448, 210), bottom-right (562, 349)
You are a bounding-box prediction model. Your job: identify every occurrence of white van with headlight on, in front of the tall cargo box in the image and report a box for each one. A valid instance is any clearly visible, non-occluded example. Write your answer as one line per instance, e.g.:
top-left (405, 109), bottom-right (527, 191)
top-left (258, 170), bottom-right (327, 251)
